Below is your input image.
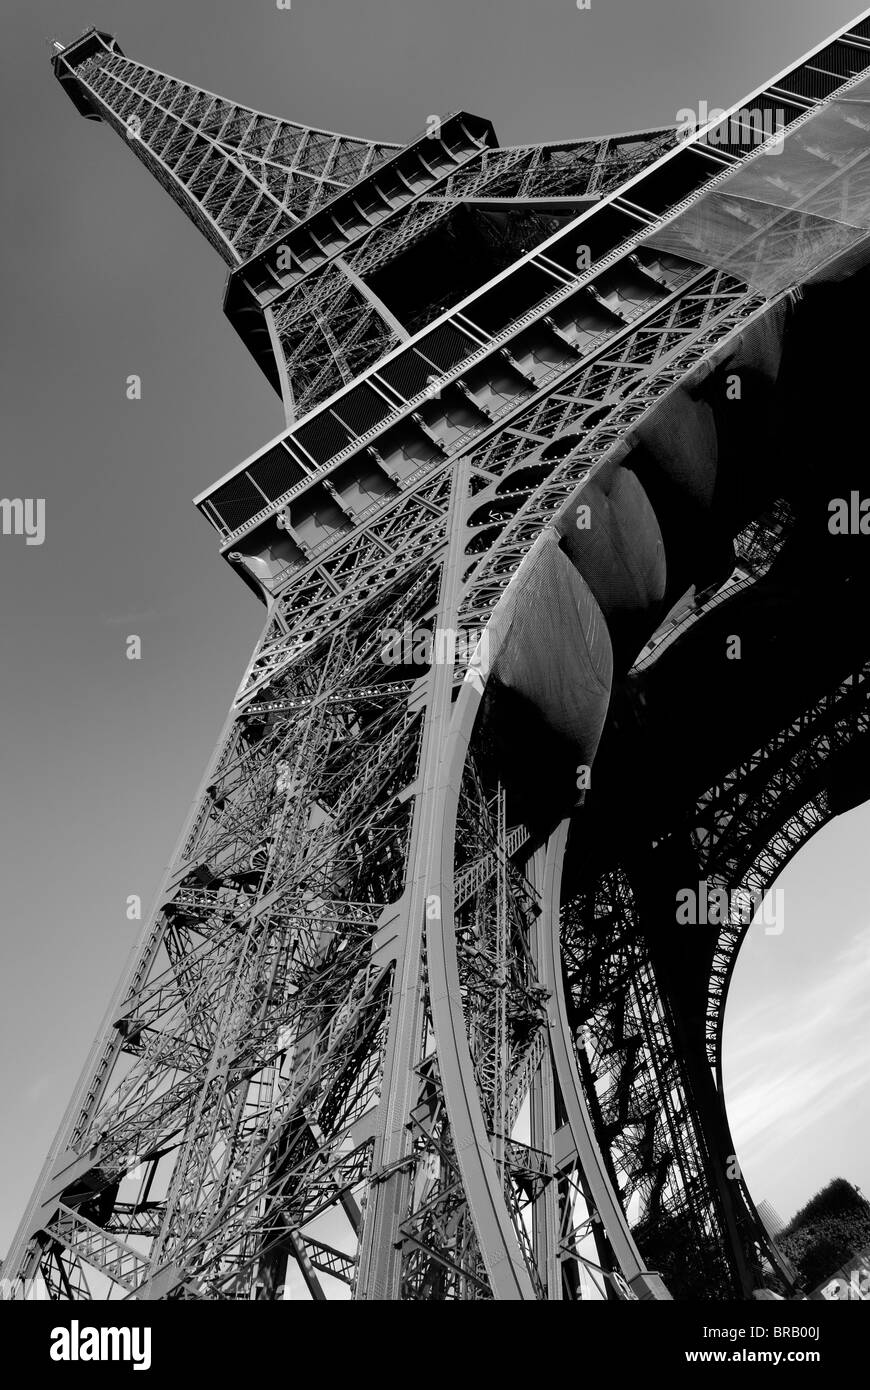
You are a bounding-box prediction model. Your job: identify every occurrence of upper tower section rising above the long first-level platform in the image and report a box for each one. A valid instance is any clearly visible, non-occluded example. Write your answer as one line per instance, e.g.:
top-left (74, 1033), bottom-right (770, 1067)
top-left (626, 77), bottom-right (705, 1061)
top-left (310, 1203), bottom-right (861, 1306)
top-left (53, 29), bottom-right (674, 424)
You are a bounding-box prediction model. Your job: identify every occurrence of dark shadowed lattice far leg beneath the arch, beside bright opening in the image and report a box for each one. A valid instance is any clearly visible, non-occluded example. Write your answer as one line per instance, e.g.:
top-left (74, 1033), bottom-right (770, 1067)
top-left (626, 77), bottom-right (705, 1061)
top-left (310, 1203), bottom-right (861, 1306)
top-left (561, 867), bottom-right (742, 1298)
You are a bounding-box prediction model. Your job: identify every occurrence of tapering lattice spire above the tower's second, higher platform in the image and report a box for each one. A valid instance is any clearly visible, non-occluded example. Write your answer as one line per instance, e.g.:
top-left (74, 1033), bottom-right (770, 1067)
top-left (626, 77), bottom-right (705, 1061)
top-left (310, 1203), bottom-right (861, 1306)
top-left (51, 29), bottom-right (400, 267)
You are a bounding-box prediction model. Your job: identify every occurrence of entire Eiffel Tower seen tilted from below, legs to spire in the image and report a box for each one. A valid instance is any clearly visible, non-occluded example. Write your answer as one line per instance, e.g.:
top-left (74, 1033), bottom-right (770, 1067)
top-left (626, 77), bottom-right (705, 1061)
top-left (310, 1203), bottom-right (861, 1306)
top-left (3, 11), bottom-right (870, 1301)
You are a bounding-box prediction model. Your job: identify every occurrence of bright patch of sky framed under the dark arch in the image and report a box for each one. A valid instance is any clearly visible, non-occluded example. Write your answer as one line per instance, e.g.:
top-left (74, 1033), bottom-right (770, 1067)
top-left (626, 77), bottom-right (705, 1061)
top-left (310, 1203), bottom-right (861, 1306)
top-left (723, 805), bottom-right (870, 1220)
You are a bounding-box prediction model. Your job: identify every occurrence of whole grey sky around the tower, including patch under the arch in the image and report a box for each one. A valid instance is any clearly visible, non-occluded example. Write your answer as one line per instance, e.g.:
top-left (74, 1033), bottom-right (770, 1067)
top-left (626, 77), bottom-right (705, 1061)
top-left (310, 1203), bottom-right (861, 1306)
top-left (0, 0), bottom-right (870, 1254)
